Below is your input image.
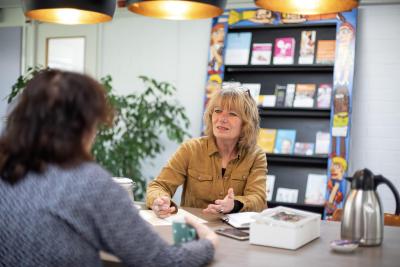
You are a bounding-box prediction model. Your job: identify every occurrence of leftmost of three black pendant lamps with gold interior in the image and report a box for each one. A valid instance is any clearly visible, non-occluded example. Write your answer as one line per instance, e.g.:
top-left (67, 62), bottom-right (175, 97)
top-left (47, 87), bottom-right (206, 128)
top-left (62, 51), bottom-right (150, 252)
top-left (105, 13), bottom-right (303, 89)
top-left (22, 0), bottom-right (116, 24)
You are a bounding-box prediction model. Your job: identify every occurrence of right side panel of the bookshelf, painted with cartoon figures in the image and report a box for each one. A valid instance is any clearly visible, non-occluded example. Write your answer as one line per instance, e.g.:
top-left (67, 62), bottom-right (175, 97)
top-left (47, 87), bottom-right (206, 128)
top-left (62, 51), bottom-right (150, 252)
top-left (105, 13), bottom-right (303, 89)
top-left (325, 9), bottom-right (357, 219)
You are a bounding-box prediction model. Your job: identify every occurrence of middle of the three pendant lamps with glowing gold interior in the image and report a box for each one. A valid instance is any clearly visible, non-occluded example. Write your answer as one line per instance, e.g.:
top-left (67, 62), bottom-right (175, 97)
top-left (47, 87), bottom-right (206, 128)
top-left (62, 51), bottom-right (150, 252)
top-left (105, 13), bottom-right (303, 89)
top-left (126, 0), bottom-right (226, 20)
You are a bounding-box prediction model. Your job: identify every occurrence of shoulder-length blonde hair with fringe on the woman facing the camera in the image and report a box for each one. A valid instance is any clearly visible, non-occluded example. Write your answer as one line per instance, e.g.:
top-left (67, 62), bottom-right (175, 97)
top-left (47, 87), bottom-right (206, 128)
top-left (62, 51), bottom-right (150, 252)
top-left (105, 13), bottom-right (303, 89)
top-left (204, 86), bottom-right (260, 153)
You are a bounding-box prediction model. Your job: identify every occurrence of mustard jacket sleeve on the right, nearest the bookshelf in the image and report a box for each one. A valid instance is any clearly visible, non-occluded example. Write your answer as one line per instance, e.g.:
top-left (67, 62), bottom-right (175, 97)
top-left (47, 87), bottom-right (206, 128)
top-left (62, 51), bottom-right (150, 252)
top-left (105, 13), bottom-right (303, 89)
top-left (235, 149), bottom-right (267, 211)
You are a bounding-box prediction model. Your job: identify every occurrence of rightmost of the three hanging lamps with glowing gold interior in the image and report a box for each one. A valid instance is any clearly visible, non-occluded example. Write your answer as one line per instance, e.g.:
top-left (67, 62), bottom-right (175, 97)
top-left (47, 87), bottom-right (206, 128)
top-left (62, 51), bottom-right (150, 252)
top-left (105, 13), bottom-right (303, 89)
top-left (254, 0), bottom-right (360, 15)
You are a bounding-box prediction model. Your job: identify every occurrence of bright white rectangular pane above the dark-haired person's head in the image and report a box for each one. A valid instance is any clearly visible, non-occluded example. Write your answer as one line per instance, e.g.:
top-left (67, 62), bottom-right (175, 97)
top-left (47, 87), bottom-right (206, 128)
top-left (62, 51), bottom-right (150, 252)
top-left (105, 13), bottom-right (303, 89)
top-left (46, 37), bottom-right (85, 73)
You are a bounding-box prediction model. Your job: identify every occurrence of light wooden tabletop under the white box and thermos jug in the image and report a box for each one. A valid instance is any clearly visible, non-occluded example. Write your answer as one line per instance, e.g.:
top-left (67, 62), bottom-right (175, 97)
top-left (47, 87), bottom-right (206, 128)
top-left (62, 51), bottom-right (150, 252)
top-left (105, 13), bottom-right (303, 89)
top-left (101, 208), bottom-right (400, 267)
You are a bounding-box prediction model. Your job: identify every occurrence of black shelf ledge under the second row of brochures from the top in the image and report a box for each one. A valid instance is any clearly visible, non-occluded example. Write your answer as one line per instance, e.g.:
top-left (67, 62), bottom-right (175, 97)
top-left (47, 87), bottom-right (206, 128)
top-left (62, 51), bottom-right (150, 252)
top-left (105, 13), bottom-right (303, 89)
top-left (258, 107), bottom-right (331, 119)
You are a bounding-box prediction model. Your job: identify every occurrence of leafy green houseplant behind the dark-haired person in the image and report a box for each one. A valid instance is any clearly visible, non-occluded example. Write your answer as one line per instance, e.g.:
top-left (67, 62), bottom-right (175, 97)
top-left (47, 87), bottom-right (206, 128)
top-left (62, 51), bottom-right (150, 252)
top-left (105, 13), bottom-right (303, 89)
top-left (7, 67), bottom-right (189, 200)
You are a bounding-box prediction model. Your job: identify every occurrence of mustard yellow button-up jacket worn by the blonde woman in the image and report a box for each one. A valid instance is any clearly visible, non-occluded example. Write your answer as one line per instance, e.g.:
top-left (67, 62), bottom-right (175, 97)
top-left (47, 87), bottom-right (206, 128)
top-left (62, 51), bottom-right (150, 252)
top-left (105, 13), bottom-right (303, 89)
top-left (146, 137), bottom-right (267, 211)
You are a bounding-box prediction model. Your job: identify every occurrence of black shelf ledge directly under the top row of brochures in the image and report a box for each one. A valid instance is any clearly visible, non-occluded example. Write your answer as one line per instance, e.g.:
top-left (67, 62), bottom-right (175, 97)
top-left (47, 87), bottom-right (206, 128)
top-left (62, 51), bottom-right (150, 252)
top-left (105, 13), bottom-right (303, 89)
top-left (225, 64), bottom-right (333, 72)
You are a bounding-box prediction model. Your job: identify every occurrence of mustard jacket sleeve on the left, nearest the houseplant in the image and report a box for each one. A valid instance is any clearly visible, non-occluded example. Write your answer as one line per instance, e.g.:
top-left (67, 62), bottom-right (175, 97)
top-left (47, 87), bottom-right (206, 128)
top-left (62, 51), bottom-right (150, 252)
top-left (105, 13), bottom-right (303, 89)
top-left (146, 143), bottom-right (190, 208)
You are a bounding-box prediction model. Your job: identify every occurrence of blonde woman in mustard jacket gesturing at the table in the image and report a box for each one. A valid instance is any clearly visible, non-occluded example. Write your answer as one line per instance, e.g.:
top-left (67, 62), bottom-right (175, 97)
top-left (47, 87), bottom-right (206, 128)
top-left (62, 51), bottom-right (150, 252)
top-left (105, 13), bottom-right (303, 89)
top-left (146, 86), bottom-right (267, 218)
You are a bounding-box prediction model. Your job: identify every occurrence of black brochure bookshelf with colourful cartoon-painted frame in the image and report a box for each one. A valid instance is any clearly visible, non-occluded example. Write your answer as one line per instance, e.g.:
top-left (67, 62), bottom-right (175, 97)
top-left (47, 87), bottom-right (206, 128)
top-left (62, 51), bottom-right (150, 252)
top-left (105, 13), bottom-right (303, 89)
top-left (205, 8), bottom-right (357, 217)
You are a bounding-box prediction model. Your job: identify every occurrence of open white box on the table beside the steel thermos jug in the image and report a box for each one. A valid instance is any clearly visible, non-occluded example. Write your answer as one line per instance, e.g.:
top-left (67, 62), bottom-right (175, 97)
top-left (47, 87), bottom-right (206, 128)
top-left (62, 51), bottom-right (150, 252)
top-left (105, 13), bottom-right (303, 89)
top-left (250, 206), bottom-right (321, 249)
